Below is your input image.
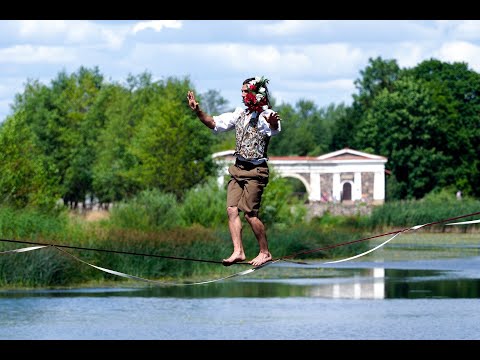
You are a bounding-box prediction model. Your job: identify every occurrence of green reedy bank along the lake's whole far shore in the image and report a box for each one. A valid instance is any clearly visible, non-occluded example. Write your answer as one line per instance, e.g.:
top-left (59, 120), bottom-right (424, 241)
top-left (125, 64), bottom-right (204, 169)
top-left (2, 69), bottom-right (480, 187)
top-left (0, 202), bottom-right (480, 289)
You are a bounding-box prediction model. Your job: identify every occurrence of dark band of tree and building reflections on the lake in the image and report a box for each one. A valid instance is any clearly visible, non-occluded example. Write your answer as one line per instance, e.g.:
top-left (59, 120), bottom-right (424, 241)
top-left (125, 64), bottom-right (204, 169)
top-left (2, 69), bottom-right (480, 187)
top-left (0, 263), bottom-right (480, 300)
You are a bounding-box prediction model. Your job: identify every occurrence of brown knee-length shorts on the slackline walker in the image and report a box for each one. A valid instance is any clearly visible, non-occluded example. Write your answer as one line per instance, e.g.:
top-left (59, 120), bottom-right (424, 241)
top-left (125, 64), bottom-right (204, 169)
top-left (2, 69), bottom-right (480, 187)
top-left (227, 159), bottom-right (269, 216)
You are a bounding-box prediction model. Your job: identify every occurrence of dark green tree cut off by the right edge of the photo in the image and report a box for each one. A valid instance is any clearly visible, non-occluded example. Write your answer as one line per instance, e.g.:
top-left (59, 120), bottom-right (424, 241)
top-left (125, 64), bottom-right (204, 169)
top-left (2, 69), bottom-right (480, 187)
top-left (409, 59), bottom-right (480, 196)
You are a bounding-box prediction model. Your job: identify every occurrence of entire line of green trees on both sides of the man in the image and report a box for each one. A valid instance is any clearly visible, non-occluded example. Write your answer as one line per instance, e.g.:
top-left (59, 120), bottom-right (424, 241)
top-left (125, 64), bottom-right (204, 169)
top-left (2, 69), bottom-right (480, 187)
top-left (0, 58), bottom-right (480, 209)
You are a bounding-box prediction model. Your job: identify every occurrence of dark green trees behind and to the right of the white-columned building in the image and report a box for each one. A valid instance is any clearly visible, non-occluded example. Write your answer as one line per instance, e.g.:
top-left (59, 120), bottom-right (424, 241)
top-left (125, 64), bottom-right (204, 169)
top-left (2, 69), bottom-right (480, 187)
top-left (270, 58), bottom-right (480, 201)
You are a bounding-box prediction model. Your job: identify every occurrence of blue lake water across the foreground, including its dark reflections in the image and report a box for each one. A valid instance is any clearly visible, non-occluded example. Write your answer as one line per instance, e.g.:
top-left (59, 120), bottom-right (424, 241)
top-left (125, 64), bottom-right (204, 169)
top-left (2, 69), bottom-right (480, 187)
top-left (0, 256), bottom-right (480, 340)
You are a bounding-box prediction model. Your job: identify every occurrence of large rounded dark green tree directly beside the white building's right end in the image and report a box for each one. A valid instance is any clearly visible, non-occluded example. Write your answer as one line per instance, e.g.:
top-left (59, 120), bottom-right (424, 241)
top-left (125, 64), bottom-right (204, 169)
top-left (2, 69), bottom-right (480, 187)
top-left (356, 76), bottom-right (451, 199)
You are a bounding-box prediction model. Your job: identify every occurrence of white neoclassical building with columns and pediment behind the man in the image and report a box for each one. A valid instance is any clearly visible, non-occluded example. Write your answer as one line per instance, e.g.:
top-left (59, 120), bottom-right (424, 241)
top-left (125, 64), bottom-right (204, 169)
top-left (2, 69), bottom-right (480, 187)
top-left (213, 148), bottom-right (387, 205)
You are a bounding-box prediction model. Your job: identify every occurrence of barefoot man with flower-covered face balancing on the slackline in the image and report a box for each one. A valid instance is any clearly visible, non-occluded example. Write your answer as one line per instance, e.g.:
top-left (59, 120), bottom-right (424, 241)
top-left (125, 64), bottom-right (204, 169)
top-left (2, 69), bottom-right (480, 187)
top-left (187, 76), bottom-right (281, 266)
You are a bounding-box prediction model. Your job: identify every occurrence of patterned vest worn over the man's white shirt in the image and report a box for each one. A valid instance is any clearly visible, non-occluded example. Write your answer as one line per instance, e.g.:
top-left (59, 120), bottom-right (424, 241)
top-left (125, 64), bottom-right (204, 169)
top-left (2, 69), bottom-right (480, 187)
top-left (234, 111), bottom-right (270, 160)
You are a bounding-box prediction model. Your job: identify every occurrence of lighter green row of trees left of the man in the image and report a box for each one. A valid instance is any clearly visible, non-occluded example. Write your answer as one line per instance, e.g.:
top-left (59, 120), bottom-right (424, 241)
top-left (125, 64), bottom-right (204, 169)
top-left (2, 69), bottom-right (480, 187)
top-left (0, 67), bottom-right (215, 208)
